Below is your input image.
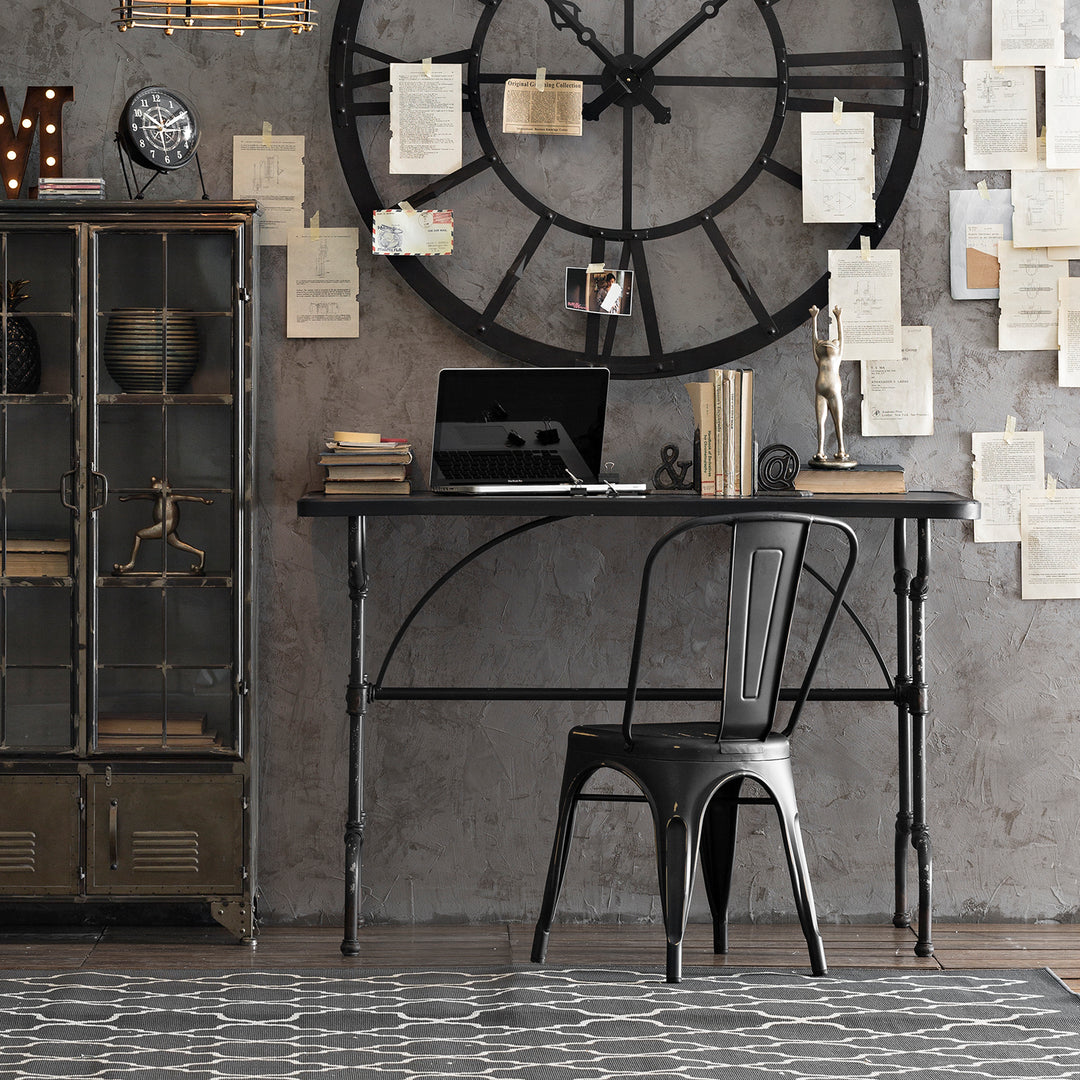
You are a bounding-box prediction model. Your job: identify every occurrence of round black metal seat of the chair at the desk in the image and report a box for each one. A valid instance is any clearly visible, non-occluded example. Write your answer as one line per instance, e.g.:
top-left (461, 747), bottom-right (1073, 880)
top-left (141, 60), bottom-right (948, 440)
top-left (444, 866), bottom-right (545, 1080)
top-left (569, 721), bottom-right (791, 762)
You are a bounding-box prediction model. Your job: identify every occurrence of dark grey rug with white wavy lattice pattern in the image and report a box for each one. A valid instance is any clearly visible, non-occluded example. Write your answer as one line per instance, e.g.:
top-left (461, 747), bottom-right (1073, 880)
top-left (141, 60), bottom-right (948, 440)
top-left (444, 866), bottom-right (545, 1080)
top-left (0, 966), bottom-right (1080, 1080)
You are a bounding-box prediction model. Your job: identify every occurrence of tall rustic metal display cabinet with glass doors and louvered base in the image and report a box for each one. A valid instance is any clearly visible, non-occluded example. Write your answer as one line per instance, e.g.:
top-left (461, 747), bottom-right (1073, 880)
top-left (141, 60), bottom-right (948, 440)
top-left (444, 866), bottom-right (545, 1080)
top-left (0, 201), bottom-right (258, 942)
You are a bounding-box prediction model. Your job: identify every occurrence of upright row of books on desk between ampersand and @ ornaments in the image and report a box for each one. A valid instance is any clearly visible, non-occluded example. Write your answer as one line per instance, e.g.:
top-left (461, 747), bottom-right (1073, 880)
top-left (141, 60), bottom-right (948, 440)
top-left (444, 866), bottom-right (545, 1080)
top-left (686, 367), bottom-right (756, 498)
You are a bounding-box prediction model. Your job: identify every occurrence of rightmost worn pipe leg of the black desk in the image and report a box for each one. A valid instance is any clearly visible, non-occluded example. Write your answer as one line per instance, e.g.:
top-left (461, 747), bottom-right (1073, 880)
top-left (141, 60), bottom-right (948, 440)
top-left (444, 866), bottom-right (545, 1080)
top-left (910, 519), bottom-right (934, 956)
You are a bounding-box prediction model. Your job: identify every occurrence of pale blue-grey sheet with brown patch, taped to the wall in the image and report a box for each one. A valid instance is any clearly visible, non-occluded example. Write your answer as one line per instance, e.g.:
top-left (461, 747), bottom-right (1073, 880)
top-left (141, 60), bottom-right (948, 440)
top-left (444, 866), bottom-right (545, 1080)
top-left (948, 186), bottom-right (1012, 300)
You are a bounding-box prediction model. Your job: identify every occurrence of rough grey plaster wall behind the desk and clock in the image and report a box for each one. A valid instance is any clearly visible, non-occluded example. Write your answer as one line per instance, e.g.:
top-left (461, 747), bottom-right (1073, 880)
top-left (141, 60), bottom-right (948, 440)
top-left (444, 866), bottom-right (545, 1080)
top-left (8, 0), bottom-right (1080, 923)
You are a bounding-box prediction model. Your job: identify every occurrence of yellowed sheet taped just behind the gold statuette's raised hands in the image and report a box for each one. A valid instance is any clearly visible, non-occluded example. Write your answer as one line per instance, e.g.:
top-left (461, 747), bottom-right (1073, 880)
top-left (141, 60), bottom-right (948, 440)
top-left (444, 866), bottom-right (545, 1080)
top-left (828, 247), bottom-right (903, 360)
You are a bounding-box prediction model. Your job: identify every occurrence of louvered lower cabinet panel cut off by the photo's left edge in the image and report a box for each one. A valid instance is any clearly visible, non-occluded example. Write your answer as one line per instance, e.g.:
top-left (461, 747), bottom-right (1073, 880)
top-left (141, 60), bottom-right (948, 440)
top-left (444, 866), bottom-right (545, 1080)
top-left (0, 777), bottom-right (79, 896)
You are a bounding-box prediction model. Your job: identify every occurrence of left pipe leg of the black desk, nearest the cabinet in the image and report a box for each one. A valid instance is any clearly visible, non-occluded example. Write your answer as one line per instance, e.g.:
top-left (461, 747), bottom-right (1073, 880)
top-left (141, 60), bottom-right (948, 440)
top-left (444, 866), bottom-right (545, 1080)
top-left (341, 517), bottom-right (368, 956)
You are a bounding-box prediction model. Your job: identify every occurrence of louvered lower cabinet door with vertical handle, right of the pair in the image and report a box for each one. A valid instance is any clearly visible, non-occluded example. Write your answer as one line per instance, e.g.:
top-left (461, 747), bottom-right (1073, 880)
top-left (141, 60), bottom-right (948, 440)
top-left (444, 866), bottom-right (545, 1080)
top-left (86, 773), bottom-right (244, 895)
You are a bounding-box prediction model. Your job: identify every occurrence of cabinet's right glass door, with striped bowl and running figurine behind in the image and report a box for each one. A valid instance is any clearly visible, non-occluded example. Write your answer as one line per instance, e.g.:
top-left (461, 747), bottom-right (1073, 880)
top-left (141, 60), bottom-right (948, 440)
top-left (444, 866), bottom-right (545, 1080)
top-left (91, 228), bottom-right (244, 755)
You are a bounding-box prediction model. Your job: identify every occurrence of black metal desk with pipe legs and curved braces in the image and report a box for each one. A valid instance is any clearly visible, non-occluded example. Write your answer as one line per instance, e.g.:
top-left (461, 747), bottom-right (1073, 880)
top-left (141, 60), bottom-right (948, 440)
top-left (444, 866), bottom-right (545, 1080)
top-left (297, 491), bottom-right (978, 956)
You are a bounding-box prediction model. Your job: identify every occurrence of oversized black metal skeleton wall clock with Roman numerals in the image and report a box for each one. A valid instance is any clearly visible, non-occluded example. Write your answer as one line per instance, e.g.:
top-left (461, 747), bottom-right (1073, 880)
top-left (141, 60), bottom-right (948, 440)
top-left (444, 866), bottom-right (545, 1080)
top-left (329, 0), bottom-right (927, 378)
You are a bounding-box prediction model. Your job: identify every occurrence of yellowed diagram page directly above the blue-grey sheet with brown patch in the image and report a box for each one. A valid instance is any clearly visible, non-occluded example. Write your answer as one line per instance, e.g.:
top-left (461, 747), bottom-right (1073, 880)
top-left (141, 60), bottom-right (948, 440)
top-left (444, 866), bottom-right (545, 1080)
top-left (963, 60), bottom-right (1039, 172)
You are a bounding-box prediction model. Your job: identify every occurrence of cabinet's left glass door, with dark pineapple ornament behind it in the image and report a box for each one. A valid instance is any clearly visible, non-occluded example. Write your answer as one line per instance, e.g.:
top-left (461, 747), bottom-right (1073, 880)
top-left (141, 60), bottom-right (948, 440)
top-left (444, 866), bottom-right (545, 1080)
top-left (0, 228), bottom-right (82, 753)
